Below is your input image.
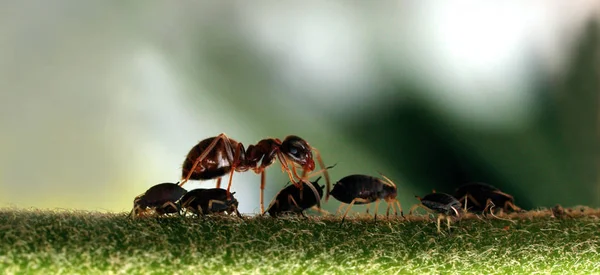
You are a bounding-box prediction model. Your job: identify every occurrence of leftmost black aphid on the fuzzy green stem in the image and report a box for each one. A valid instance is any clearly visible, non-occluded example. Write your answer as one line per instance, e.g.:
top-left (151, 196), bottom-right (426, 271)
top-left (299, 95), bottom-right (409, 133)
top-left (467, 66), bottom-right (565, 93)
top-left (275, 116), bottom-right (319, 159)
top-left (131, 182), bottom-right (187, 218)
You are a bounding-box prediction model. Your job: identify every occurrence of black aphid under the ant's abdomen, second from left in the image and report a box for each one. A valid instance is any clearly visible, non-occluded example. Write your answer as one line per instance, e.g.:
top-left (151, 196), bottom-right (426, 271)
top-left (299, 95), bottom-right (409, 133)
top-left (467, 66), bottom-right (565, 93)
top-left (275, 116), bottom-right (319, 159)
top-left (181, 188), bottom-right (242, 218)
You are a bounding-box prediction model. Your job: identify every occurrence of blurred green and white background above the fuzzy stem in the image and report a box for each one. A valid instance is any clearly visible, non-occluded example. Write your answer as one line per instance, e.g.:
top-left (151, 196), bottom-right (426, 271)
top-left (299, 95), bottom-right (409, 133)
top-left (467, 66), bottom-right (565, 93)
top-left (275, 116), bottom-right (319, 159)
top-left (0, 0), bottom-right (600, 213)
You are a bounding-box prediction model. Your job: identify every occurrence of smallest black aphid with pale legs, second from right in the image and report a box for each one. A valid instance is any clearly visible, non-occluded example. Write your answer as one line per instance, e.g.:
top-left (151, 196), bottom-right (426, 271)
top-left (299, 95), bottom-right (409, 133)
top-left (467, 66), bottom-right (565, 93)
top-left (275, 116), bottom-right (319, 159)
top-left (409, 191), bottom-right (462, 232)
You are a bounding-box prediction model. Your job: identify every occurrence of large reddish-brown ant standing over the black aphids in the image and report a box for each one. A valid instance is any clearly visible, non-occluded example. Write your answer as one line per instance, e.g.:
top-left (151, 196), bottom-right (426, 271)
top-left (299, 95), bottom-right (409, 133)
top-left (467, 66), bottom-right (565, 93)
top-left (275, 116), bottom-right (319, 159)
top-left (179, 133), bottom-right (330, 214)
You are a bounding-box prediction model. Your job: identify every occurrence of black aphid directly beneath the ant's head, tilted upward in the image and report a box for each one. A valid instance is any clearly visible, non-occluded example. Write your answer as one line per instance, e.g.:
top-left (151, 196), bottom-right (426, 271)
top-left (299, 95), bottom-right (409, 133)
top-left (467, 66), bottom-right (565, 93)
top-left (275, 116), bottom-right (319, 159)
top-left (267, 177), bottom-right (325, 217)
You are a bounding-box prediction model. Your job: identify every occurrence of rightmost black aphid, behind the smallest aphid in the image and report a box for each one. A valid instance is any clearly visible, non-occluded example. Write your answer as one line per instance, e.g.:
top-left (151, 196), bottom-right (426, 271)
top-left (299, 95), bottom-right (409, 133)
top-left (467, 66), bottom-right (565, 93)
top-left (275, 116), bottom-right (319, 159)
top-left (454, 183), bottom-right (521, 213)
